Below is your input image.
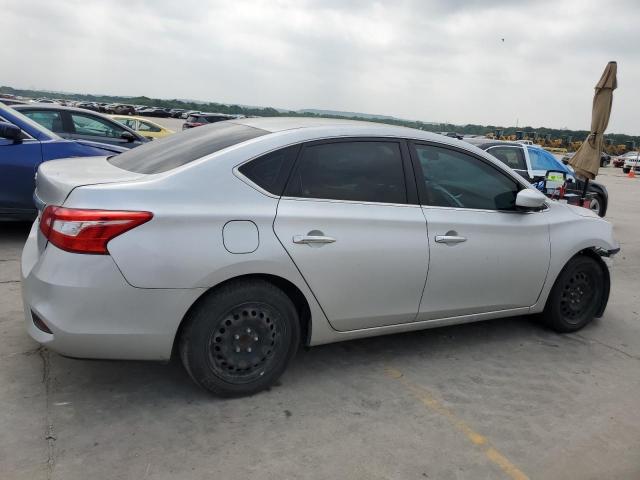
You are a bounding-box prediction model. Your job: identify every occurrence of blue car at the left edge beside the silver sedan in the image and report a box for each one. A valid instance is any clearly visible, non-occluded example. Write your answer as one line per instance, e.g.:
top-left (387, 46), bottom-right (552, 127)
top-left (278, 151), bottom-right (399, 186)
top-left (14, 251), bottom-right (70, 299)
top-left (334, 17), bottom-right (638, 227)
top-left (0, 103), bottom-right (127, 220)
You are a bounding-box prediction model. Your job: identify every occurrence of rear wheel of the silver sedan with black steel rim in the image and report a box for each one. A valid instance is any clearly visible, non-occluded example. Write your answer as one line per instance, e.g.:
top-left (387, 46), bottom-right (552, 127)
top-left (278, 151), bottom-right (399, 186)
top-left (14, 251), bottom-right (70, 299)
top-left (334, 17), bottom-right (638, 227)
top-left (179, 280), bottom-right (300, 397)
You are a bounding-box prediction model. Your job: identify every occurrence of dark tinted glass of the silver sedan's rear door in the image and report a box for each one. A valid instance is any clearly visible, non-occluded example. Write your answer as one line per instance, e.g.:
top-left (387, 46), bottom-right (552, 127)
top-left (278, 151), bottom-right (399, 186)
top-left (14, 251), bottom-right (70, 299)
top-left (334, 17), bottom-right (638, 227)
top-left (285, 141), bottom-right (407, 203)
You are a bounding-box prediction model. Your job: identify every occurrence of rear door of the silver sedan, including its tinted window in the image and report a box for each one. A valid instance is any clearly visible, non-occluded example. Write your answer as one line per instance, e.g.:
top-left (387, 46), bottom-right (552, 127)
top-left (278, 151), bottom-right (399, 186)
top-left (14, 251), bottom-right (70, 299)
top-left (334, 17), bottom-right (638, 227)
top-left (274, 139), bottom-right (429, 331)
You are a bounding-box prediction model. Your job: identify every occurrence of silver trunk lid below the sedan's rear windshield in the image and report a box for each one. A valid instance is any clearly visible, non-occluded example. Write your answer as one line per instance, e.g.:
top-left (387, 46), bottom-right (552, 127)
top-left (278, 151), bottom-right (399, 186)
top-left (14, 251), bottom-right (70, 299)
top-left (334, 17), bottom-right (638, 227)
top-left (34, 157), bottom-right (147, 207)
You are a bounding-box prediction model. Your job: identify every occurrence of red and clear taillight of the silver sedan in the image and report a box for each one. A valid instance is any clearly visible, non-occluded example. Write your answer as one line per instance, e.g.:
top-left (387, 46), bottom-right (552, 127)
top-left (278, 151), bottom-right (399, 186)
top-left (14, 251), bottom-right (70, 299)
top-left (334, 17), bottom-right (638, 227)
top-left (40, 205), bottom-right (153, 255)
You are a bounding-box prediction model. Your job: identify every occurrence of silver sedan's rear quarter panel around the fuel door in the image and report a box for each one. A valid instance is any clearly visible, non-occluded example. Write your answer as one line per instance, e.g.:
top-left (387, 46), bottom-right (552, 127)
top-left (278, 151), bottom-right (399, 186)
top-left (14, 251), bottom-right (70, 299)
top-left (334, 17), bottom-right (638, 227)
top-left (65, 137), bottom-right (331, 342)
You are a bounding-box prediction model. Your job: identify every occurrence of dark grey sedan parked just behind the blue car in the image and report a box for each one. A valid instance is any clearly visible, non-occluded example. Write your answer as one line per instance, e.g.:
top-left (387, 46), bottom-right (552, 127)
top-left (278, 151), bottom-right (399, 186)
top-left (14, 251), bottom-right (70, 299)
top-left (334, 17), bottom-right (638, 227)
top-left (14, 104), bottom-right (148, 148)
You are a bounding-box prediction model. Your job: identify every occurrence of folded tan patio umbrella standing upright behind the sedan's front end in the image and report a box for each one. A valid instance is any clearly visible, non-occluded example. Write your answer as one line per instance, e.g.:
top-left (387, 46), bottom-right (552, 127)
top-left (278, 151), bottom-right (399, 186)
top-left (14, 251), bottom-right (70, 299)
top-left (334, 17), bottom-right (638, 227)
top-left (569, 62), bottom-right (618, 180)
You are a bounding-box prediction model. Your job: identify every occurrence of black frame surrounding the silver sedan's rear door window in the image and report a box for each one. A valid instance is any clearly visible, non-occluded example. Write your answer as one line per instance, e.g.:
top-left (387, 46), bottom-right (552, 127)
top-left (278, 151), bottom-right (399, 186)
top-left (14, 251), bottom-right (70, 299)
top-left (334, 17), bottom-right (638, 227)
top-left (281, 136), bottom-right (420, 206)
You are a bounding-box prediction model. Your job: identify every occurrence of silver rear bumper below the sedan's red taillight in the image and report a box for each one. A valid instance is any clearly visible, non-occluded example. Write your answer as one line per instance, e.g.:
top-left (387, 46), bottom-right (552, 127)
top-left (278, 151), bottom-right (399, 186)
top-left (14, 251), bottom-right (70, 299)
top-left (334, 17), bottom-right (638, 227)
top-left (21, 224), bottom-right (203, 360)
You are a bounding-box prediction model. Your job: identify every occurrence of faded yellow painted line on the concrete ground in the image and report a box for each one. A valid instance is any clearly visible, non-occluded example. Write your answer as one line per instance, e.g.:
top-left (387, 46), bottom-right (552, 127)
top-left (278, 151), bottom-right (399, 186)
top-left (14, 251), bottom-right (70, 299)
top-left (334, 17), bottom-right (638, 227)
top-left (384, 368), bottom-right (529, 480)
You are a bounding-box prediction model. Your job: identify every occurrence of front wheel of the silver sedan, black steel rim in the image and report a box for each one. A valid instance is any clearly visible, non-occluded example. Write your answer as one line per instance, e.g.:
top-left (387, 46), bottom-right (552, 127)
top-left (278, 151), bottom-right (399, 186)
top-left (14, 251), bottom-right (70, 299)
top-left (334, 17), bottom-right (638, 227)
top-left (543, 255), bottom-right (605, 333)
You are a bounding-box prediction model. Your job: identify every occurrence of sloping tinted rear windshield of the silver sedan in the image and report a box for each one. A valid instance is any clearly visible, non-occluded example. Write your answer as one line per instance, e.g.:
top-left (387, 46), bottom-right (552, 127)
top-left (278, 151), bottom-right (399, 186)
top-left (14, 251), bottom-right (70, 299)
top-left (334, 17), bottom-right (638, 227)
top-left (109, 122), bottom-right (269, 173)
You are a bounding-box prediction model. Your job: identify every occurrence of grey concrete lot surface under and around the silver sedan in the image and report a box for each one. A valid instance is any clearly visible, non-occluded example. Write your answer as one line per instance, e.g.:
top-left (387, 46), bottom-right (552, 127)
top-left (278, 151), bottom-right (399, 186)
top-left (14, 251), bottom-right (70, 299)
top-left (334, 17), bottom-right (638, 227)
top-left (0, 167), bottom-right (640, 480)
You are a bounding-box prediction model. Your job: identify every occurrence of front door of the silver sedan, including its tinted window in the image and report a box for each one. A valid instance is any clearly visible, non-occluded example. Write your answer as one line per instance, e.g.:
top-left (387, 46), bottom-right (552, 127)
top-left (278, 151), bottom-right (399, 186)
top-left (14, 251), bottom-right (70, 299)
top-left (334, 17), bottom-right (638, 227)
top-left (412, 143), bottom-right (550, 320)
